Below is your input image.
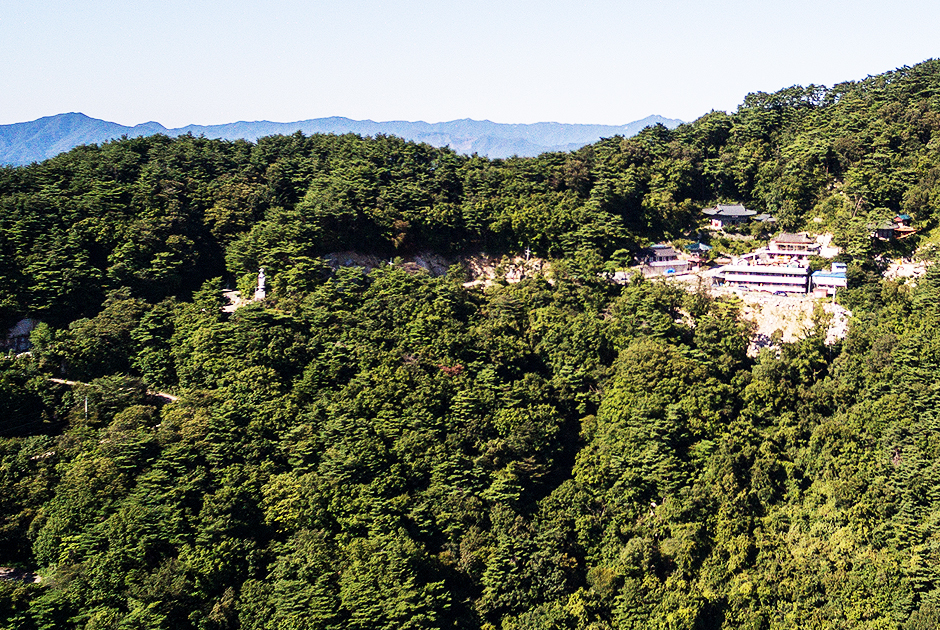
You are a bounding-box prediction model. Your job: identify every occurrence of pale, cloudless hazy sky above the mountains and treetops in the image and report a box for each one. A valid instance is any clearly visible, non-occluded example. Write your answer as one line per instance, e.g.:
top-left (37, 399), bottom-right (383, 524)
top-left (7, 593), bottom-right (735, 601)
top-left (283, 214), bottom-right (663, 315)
top-left (0, 0), bottom-right (940, 127)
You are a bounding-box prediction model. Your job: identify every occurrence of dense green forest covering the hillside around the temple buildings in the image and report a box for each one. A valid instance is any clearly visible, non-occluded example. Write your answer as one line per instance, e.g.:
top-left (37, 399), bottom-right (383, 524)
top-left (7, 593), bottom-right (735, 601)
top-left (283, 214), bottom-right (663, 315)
top-left (0, 61), bottom-right (940, 630)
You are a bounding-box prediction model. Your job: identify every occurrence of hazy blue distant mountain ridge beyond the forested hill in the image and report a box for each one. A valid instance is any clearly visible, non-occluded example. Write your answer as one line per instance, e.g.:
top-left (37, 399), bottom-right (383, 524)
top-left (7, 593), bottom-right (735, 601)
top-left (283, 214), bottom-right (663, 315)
top-left (0, 112), bottom-right (682, 166)
